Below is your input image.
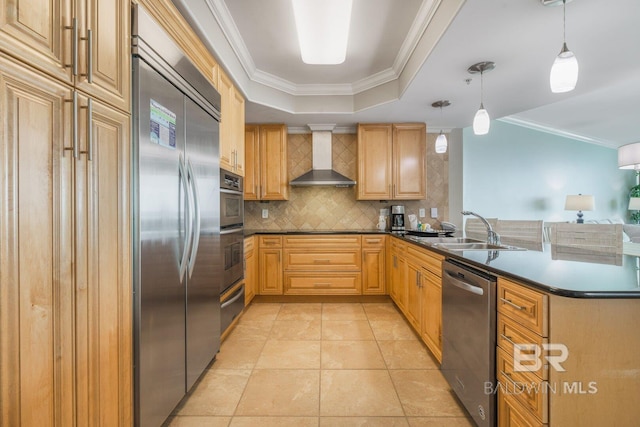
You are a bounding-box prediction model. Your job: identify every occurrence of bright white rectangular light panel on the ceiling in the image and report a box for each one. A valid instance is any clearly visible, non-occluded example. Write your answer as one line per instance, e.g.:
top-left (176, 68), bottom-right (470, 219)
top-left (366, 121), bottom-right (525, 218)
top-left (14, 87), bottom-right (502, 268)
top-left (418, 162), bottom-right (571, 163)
top-left (291, 0), bottom-right (353, 65)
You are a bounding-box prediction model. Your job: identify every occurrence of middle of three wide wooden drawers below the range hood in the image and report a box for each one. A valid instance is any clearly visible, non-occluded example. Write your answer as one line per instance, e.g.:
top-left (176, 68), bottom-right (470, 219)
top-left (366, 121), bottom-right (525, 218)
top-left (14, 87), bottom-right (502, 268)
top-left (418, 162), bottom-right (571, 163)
top-left (284, 249), bottom-right (362, 271)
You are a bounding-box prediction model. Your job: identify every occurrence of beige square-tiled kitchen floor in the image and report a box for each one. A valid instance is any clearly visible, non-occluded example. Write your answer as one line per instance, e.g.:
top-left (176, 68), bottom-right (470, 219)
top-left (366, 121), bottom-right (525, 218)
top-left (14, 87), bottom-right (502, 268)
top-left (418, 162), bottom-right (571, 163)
top-left (169, 303), bottom-right (473, 427)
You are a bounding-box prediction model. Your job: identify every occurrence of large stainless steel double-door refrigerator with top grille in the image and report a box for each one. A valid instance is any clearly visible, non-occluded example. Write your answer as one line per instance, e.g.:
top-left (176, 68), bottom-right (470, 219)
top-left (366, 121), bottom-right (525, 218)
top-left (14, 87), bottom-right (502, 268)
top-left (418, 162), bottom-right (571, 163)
top-left (132, 6), bottom-right (222, 426)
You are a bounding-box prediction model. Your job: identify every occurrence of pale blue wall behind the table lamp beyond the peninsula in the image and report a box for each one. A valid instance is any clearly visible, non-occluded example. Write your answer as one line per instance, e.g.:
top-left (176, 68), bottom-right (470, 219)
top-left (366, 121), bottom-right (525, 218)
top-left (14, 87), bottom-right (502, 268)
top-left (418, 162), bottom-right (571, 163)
top-left (460, 121), bottom-right (635, 221)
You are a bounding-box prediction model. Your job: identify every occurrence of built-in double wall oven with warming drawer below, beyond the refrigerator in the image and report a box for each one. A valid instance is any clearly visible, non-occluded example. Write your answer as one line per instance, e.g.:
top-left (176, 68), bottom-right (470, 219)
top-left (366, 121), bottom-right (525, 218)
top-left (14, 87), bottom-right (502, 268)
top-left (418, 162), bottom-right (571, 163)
top-left (220, 169), bottom-right (244, 331)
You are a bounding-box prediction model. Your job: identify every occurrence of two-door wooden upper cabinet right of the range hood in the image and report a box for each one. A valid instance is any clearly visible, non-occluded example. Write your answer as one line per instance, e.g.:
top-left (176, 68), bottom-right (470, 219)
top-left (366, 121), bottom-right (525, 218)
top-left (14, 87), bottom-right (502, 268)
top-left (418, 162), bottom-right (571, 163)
top-left (357, 123), bottom-right (427, 200)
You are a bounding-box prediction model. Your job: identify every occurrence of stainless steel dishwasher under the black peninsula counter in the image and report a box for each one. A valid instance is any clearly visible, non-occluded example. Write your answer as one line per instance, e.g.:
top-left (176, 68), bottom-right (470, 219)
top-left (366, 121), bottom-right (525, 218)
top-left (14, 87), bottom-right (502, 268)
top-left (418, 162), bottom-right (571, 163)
top-left (441, 260), bottom-right (496, 426)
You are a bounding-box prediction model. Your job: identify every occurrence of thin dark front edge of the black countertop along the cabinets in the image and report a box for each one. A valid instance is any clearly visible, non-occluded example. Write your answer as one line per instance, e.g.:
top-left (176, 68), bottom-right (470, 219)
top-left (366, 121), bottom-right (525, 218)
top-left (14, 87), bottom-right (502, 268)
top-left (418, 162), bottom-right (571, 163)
top-left (244, 230), bottom-right (640, 299)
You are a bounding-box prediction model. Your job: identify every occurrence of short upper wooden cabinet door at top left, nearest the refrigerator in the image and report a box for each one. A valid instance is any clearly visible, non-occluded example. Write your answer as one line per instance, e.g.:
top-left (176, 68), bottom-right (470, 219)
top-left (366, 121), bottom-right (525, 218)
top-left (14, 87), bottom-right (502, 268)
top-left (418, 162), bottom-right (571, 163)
top-left (76, 0), bottom-right (131, 111)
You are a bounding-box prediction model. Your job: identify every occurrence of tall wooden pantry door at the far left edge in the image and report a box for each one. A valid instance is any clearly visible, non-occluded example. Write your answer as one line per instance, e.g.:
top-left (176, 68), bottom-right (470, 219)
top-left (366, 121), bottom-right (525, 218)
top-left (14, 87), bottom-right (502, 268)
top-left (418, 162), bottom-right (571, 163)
top-left (0, 55), bottom-right (75, 426)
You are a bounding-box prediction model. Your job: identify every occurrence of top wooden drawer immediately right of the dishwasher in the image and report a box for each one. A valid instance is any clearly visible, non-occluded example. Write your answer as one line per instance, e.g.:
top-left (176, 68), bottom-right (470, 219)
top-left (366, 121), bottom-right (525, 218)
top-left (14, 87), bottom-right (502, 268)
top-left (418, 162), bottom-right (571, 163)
top-left (497, 277), bottom-right (549, 337)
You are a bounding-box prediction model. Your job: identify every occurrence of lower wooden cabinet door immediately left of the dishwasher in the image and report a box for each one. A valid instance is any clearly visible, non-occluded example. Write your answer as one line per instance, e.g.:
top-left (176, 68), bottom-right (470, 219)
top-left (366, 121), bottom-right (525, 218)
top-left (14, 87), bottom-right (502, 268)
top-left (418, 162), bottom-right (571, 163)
top-left (420, 270), bottom-right (442, 362)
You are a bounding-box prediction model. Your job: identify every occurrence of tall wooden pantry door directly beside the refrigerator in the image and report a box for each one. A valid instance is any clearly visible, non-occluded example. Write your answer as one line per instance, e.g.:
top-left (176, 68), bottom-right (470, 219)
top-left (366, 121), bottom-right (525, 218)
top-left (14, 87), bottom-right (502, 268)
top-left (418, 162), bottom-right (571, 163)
top-left (75, 97), bottom-right (133, 426)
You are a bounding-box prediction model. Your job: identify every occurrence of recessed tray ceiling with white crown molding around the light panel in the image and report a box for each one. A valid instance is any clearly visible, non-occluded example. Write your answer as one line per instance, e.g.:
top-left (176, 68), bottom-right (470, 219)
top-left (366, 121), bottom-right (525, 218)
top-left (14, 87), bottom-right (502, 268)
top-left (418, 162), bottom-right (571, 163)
top-left (174, 0), bottom-right (464, 114)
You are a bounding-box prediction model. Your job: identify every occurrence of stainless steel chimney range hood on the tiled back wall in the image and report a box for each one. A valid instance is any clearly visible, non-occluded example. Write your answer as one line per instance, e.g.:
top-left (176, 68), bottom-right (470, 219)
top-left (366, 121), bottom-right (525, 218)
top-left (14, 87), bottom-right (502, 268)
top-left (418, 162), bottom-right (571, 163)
top-left (289, 125), bottom-right (356, 187)
